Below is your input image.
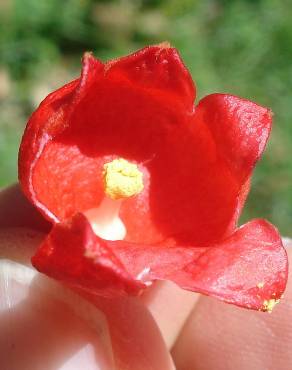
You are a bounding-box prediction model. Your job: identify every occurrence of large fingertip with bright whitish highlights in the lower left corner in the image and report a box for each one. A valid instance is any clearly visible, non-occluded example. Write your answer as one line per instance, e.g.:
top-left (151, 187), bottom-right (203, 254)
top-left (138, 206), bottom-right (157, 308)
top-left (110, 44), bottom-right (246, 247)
top-left (0, 228), bottom-right (115, 370)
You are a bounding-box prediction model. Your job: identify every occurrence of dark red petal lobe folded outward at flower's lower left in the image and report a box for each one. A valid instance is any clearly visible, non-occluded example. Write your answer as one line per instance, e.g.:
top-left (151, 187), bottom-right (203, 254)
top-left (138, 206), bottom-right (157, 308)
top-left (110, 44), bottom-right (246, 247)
top-left (32, 215), bottom-right (145, 297)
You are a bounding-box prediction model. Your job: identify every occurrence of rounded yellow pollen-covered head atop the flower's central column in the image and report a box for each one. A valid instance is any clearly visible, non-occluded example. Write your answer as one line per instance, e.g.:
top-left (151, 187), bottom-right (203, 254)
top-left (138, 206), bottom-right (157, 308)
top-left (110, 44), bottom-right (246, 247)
top-left (103, 158), bottom-right (144, 200)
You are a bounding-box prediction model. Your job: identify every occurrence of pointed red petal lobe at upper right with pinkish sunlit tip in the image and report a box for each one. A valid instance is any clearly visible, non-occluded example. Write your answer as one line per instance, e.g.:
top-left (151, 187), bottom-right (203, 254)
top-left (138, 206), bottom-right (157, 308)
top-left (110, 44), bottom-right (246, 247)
top-left (196, 94), bottom-right (272, 183)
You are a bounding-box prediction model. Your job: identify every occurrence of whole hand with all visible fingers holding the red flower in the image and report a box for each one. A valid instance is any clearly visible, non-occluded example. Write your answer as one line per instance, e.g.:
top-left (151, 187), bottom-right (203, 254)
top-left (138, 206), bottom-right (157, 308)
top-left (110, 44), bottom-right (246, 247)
top-left (0, 186), bottom-right (292, 370)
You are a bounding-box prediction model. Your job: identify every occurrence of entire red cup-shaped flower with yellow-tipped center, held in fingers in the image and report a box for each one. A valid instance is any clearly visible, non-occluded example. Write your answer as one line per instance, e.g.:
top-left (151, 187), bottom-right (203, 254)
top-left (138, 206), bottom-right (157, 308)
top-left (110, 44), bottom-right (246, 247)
top-left (19, 44), bottom-right (287, 311)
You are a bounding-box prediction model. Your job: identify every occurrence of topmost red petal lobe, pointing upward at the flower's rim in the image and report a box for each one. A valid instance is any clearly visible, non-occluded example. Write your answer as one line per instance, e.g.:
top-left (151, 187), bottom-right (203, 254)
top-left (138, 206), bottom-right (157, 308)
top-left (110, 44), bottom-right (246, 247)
top-left (106, 43), bottom-right (196, 112)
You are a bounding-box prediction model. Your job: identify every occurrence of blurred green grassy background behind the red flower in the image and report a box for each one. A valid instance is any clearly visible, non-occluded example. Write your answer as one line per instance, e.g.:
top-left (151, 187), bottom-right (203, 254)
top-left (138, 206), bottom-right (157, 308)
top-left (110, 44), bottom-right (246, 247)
top-left (0, 0), bottom-right (292, 236)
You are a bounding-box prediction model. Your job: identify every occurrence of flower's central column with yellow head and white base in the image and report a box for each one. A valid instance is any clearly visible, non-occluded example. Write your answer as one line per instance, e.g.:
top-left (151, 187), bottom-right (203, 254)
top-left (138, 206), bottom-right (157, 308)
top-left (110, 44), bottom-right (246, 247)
top-left (85, 158), bottom-right (144, 240)
